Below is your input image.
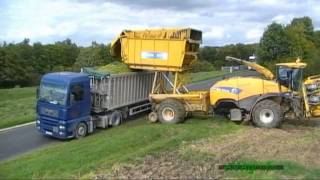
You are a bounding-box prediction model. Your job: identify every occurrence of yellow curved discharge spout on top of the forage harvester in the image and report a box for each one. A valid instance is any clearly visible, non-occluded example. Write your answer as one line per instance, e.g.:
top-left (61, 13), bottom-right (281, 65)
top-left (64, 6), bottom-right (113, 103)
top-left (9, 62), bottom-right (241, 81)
top-left (226, 56), bottom-right (274, 80)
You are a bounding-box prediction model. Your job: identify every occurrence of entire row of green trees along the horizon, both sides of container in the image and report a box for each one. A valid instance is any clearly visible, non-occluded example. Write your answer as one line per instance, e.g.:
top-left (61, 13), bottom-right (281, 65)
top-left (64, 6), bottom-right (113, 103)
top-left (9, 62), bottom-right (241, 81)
top-left (0, 17), bottom-right (320, 88)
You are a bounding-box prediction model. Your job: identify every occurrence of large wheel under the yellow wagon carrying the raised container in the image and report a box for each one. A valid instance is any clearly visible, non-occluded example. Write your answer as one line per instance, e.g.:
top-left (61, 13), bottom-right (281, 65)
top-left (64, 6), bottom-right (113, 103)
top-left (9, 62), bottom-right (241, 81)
top-left (158, 99), bottom-right (186, 124)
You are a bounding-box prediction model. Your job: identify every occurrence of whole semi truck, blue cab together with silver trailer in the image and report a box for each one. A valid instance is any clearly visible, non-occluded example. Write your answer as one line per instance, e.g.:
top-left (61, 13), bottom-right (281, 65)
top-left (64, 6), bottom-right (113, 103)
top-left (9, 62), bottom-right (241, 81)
top-left (36, 69), bottom-right (154, 139)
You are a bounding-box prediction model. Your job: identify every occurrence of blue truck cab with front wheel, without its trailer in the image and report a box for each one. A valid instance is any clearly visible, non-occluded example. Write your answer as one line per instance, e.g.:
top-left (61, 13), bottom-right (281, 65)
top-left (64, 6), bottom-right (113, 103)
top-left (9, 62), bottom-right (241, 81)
top-left (36, 72), bottom-right (93, 139)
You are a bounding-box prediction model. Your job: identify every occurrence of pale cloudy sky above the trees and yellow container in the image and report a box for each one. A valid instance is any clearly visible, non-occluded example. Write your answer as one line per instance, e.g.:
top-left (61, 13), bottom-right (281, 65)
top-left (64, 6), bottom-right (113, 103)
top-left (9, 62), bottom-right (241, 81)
top-left (0, 0), bottom-right (320, 46)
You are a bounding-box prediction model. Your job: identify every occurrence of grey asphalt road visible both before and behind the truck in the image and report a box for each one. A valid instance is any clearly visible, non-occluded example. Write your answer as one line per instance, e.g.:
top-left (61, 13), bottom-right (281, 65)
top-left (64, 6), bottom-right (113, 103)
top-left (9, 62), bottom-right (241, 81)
top-left (0, 71), bottom-right (257, 162)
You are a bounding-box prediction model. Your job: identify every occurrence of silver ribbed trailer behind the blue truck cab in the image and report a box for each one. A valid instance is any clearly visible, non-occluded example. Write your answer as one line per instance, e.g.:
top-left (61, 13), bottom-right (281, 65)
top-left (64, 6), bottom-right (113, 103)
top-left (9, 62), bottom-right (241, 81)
top-left (84, 71), bottom-right (154, 128)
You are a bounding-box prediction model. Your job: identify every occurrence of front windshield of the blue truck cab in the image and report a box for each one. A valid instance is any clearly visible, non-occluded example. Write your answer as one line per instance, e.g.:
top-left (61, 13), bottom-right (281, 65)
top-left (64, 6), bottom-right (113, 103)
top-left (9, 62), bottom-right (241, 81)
top-left (39, 83), bottom-right (67, 105)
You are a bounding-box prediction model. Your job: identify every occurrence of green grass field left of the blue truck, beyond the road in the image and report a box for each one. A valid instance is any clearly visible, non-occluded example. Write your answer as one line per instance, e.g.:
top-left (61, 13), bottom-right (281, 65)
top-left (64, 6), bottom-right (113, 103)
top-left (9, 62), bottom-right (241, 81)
top-left (0, 87), bottom-right (36, 129)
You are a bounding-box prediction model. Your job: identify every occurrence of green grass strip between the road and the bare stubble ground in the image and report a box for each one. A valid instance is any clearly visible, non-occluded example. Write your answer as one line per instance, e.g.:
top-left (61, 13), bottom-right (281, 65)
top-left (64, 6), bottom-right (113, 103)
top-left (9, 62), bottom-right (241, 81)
top-left (0, 117), bottom-right (243, 179)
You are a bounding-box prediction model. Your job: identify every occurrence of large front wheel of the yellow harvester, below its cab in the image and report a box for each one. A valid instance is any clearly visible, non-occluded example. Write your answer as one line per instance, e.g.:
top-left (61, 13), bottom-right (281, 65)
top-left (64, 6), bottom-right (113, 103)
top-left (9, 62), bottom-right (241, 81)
top-left (252, 99), bottom-right (283, 128)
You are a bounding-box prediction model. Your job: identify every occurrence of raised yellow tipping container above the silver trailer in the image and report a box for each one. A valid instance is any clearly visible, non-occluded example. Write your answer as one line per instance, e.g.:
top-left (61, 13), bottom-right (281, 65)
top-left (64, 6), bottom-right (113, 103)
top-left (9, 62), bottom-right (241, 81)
top-left (111, 28), bottom-right (202, 72)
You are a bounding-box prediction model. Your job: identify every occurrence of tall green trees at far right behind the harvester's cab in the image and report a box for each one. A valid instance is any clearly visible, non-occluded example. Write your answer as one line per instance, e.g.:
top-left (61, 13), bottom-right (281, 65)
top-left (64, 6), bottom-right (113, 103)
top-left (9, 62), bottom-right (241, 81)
top-left (257, 17), bottom-right (320, 76)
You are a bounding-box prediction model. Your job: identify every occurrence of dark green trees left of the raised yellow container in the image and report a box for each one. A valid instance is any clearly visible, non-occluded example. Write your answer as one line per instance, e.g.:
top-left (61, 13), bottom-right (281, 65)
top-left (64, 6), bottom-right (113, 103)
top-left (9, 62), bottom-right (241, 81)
top-left (0, 39), bottom-right (114, 88)
